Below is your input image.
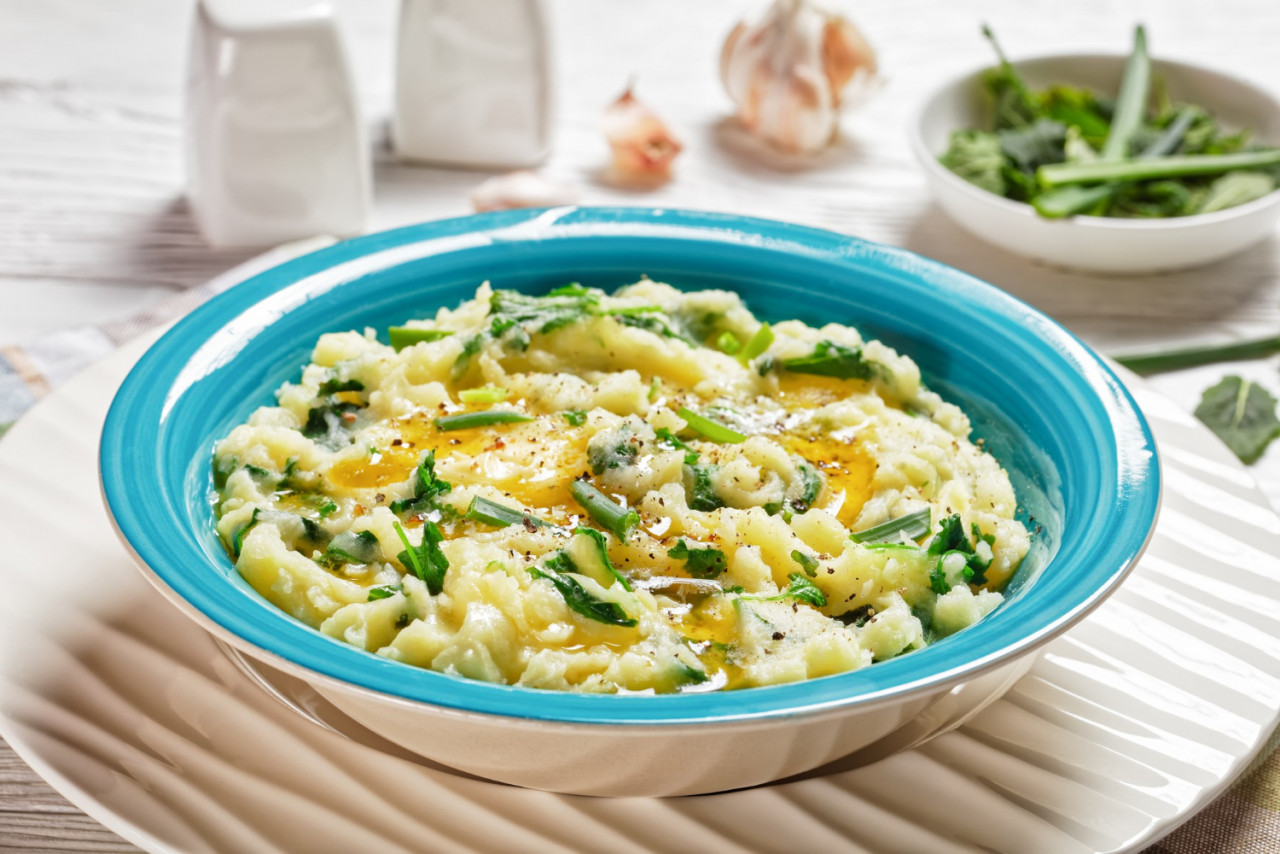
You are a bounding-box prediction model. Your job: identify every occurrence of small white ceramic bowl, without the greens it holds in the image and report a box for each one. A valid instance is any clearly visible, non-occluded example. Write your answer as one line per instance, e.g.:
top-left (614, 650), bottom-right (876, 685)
top-left (910, 54), bottom-right (1280, 274)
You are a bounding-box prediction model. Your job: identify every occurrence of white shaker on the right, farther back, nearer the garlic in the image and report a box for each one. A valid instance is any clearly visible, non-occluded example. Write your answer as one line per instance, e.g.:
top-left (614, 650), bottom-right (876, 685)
top-left (392, 0), bottom-right (554, 168)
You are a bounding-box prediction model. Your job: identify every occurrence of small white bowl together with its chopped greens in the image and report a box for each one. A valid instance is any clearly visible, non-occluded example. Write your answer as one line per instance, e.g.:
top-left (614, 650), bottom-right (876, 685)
top-left (911, 28), bottom-right (1280, 274)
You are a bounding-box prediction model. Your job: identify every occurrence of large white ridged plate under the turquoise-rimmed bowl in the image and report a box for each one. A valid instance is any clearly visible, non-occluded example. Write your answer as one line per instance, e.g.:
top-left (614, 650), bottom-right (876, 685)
top-left (0, 330), bottom-right (1280, 854)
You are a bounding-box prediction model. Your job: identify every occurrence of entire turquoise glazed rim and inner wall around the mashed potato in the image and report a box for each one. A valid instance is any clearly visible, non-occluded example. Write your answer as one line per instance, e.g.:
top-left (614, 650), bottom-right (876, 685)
top-left (101, 207), bottom-right (1160, 723)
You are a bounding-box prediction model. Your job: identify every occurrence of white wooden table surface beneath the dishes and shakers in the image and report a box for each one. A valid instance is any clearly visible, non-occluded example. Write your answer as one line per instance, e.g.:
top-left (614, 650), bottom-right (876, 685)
top-left (0, 0), bottom-right (1280, 851)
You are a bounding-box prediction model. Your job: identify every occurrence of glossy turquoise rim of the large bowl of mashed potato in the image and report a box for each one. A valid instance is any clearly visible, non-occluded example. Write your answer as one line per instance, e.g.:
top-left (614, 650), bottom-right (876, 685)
top-left (100, 206), bottom-right (1161, 726)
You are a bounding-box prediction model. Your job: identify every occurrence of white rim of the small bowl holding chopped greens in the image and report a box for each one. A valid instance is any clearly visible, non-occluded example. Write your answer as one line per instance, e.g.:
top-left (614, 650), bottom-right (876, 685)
top-left (908, 51), bottom-right (1280, 233)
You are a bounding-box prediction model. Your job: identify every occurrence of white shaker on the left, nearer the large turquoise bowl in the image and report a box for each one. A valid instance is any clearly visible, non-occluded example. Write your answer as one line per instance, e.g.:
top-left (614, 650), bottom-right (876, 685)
top-left (186, 0), bottom-right (370, 246)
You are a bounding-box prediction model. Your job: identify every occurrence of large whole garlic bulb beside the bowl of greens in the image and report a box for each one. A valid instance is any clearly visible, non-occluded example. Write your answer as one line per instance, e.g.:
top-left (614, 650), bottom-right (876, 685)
top-left (721, 0), bottom-right (879, 152)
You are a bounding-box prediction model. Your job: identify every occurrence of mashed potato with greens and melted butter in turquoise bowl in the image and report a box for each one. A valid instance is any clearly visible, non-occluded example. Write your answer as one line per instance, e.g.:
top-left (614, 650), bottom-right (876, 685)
top-left (214, 280), bottom-right (1028, 691)
